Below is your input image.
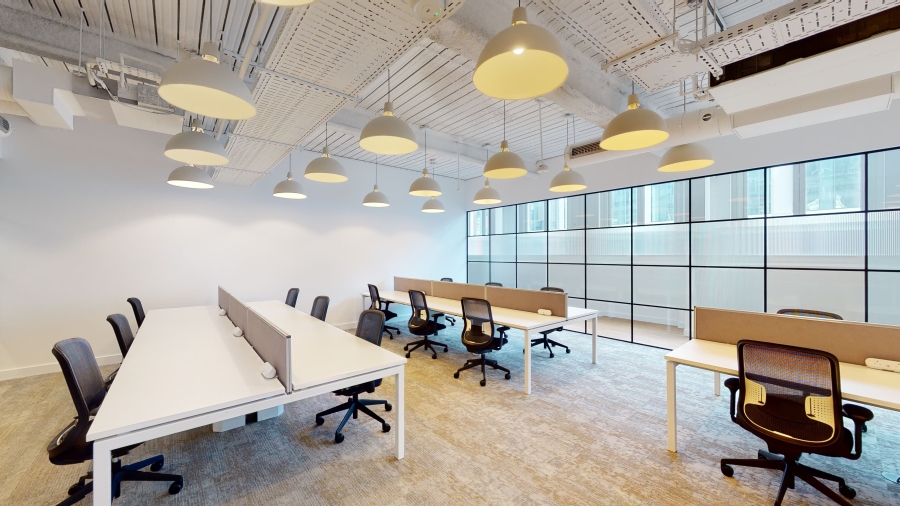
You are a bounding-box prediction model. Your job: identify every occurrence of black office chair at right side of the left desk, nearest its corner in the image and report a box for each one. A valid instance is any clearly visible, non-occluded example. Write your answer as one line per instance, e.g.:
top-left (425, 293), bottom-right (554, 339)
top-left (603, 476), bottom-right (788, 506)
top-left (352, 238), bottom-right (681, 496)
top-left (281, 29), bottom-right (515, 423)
top-left (316, 310), bottom-right (392, 443)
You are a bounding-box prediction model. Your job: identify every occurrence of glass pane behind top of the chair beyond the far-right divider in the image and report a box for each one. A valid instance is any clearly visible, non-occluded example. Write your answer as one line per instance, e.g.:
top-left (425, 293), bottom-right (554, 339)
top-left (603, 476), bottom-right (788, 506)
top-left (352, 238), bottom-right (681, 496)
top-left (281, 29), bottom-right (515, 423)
top-left (766, 269), bottom-right (865, 321)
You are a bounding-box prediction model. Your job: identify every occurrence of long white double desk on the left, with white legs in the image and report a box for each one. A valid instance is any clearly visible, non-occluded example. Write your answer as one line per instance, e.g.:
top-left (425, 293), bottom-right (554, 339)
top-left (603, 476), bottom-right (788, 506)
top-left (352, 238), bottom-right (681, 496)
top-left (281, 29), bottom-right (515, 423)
top-left (87, 301), bottom-right (406, 506)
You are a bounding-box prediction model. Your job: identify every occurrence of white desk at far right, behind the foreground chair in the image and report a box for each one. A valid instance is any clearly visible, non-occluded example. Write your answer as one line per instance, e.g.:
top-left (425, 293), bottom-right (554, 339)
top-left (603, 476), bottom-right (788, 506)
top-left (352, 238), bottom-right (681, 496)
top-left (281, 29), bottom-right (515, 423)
top-left (666, 339), bottom-right (900, 452)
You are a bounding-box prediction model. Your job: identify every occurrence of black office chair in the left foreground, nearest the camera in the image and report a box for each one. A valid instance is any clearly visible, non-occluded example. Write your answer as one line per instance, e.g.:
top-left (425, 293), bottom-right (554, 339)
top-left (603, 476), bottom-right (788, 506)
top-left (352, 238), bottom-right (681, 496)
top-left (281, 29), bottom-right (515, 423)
top-left (47, 337), bottom-right (184, 506)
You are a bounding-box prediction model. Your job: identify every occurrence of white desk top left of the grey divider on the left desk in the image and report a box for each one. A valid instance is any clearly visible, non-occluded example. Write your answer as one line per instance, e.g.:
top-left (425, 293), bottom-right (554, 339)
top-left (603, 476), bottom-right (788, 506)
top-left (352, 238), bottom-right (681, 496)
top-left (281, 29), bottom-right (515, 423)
top-left (87, 306), bottom-right (284, 441)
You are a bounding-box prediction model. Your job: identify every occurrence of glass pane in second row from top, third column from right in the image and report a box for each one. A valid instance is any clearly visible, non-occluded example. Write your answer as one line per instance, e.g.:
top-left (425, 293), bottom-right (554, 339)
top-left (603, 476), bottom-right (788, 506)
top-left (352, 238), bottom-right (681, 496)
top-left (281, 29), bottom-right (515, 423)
top-left (691, 220), bottom-right (763, 267)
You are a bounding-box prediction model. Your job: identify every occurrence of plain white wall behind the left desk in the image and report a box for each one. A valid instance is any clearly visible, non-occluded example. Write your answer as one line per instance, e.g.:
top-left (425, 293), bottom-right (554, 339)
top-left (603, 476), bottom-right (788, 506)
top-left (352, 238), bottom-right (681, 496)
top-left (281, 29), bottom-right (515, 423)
top-left (0, 118), bottom-right (466, 379)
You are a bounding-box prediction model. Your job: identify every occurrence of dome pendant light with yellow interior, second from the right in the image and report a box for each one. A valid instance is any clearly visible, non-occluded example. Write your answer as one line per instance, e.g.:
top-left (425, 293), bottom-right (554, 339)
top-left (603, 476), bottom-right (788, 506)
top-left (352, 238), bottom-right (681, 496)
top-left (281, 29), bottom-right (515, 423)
top-left (600, 83), bottom-right (669, 151)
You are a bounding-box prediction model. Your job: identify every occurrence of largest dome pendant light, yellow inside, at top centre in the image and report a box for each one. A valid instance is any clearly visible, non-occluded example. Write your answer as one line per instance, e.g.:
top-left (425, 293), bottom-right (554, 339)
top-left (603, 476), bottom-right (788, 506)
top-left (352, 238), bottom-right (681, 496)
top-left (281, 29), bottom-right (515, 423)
top-left (472, 3), bottom-right (569, 100)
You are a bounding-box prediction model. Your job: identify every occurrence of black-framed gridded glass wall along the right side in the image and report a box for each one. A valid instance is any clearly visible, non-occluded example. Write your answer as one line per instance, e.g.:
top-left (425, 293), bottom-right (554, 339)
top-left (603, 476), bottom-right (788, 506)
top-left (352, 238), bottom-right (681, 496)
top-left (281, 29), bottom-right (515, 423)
top-left (468, 149), bottom-right (900, 348)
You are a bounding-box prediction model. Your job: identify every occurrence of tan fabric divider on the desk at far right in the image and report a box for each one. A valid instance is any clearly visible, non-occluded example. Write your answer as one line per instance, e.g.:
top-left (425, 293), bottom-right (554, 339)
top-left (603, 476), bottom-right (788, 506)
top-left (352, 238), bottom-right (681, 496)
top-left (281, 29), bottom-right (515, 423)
top-left (694, 307), bottom-right (900, 365)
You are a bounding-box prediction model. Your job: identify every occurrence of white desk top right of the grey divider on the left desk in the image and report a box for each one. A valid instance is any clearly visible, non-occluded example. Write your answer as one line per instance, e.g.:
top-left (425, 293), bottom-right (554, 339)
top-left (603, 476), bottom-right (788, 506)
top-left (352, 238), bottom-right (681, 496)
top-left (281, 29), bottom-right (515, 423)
top-left (244, 300), bottom-right (406, 390)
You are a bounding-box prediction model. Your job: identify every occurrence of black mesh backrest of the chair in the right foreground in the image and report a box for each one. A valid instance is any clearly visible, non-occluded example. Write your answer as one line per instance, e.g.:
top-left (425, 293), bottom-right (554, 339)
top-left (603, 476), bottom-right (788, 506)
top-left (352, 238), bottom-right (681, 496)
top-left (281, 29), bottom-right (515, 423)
top-left (738, 340), bottom-right (843, 447)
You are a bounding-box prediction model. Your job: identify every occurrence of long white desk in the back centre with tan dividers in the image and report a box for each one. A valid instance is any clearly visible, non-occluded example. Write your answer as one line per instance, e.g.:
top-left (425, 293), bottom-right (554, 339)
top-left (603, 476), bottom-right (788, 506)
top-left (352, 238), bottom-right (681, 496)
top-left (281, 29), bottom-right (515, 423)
top-left (361, 290), bottom-right (598, 394)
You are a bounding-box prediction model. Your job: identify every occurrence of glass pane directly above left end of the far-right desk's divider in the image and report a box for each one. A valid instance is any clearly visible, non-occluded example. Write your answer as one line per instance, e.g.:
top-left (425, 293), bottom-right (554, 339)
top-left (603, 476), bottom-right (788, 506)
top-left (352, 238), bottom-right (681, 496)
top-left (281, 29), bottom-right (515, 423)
top-left (691, 268), bottom-right (765, 313)
